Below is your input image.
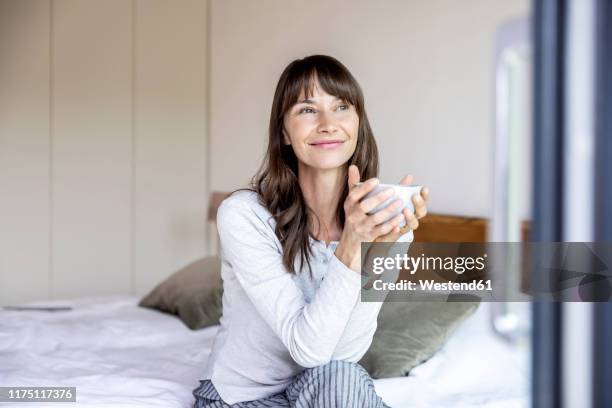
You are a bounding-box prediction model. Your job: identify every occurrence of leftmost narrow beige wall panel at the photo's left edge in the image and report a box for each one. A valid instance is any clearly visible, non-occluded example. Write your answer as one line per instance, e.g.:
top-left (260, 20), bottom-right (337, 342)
top-left (0, 0), bottom-right (50, 304)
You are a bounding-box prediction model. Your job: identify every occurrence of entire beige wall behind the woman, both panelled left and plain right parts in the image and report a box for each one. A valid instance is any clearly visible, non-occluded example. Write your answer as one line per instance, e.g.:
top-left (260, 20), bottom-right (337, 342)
top-left (0, 0), bottom-right (529, 304)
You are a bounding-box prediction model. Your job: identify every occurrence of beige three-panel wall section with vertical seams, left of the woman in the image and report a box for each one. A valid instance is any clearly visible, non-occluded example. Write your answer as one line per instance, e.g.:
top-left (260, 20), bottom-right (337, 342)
top-left (0, 0), bottom-right (208, 304)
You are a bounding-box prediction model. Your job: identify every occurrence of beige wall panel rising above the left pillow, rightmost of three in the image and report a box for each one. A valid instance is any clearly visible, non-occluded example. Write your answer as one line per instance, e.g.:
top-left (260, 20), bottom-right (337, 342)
top-left (133, 0), bottom-right (207, 293)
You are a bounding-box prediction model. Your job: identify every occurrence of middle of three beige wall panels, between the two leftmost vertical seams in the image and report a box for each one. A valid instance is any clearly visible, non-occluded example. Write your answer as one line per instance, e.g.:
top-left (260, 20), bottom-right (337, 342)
top-left (52, 0), bottom-right (133, 297)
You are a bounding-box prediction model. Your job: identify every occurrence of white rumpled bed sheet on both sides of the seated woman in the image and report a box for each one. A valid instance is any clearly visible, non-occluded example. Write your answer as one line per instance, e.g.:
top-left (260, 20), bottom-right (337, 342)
top-left (0, 296), bottom-right (528, 408)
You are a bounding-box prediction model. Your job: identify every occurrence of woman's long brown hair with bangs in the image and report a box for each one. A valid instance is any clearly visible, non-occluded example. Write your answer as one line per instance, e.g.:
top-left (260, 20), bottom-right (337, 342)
top-left (231, 55), bottom-right (378, 273)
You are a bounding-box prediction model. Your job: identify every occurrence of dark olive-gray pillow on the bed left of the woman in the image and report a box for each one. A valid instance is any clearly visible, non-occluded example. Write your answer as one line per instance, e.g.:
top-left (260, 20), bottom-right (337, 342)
top-left (138, 256), bottom-right (223, 330)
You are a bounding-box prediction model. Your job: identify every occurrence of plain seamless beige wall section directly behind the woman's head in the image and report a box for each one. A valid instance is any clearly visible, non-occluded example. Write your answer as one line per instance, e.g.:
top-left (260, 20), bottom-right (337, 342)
top-left (210, 0), bottom-right (529, 216)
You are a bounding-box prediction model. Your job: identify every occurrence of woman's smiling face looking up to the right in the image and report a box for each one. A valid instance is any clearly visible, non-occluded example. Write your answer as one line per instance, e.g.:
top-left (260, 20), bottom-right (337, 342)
top-left (283, 82), bottom-right (359, 170)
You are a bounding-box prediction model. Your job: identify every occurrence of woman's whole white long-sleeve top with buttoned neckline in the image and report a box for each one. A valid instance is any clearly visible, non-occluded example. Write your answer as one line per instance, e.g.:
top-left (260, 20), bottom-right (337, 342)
top-left (203, 191), bottom-right (413, 404)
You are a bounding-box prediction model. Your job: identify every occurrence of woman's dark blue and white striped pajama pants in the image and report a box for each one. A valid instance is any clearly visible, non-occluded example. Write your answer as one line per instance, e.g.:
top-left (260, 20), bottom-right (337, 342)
top-left (193, 360), bottom-right (390, 408)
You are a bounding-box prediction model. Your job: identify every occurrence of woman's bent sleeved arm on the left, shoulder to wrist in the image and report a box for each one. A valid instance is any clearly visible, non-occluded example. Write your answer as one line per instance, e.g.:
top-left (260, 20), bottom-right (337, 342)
top-left (217, 199), bottom-right (361, 367)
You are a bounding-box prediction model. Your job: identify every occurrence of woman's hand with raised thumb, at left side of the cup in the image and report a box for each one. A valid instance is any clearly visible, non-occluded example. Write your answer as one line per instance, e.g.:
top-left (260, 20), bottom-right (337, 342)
top-left (336, 164), bottom-right (404, 272)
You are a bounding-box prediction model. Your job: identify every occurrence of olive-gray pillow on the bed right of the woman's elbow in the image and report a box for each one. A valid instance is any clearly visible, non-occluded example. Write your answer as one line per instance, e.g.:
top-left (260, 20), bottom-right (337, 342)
top-left (359, 301), bottom-right (479, 378)
